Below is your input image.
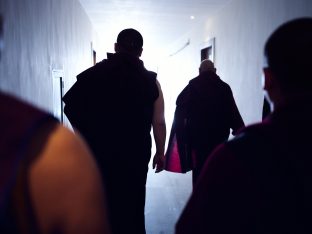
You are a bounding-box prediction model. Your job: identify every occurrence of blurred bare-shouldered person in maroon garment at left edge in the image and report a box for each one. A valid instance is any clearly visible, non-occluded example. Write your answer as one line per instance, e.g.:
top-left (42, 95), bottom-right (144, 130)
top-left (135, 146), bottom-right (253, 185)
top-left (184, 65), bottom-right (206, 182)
top-left (0, 16), bottom-right (110, 234)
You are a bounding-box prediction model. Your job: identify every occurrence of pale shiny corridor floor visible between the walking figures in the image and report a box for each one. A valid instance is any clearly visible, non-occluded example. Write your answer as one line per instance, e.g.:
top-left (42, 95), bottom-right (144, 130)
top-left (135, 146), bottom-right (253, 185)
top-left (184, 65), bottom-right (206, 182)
top-left (145, 165), bottom-right (192, 234)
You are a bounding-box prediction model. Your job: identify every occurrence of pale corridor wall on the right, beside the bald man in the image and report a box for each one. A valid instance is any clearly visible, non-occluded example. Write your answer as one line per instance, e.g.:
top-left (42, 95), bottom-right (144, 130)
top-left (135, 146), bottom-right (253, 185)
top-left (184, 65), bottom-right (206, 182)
top-left (200, 0), bottom-right (312, 124)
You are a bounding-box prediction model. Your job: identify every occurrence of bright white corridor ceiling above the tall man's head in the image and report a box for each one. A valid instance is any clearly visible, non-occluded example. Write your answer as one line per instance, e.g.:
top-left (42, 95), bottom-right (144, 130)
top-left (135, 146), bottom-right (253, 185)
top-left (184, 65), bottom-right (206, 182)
top-left (80, 0), bottom-right (231, 55)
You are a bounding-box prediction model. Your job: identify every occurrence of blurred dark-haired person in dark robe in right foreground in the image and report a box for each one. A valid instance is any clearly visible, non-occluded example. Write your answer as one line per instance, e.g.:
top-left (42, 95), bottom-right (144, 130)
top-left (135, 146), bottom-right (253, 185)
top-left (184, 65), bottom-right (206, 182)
top-left (176, 18), bottom-right (312, 234)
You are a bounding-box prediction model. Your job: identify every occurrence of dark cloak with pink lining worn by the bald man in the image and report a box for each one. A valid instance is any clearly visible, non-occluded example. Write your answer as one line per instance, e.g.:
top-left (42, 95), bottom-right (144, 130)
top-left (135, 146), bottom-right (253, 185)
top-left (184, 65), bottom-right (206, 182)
top-left (166, 71), bottom-right (244, 172)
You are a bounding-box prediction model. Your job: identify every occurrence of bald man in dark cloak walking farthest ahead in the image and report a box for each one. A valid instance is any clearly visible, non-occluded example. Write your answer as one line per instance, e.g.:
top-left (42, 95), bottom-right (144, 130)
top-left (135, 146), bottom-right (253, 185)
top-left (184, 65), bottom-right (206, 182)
top-left (166, 59), bottom-right (244, 185)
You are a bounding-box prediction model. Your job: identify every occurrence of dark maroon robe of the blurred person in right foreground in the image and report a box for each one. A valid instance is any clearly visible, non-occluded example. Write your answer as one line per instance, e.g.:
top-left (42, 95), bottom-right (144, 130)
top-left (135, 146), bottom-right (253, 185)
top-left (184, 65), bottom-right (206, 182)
top-left (176, 100), bottom-right (312, 234)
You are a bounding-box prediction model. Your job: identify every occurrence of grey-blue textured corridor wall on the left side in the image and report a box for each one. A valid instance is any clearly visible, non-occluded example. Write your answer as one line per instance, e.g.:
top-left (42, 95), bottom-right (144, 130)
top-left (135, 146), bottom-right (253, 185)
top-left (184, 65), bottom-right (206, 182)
top-left (0, 0), bottom-right (94, 115)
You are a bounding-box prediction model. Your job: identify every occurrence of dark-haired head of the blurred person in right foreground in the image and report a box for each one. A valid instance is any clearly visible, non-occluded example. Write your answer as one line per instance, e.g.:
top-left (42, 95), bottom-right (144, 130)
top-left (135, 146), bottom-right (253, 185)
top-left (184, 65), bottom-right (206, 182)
top-left (264, 18), bottom-right (312, 108)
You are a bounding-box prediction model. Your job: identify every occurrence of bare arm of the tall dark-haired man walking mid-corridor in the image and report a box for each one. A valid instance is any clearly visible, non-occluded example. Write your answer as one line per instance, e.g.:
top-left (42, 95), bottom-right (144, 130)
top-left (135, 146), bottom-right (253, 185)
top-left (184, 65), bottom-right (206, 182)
top-left (152, 80), bottom-right (166, 172)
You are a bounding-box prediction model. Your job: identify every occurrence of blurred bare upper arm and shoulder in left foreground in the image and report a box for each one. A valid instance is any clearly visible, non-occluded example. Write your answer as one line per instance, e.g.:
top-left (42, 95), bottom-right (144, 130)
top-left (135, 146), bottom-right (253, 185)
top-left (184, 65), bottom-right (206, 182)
top-left (29, 125), bottom-right (110, 234)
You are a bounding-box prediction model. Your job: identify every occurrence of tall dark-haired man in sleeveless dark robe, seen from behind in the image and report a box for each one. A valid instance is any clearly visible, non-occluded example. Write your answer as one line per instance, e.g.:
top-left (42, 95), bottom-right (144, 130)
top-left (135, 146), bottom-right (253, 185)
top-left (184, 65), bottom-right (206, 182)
top-left (63, 29), bottom-right (166, 234)
